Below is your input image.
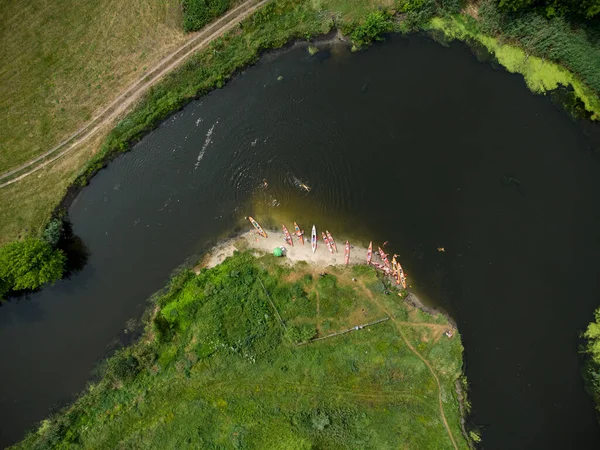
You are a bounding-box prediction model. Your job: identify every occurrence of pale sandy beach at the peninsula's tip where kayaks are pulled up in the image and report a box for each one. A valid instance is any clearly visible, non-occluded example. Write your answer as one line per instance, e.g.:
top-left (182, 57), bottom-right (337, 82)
top-left (201, 231), bottom-right (367, 267)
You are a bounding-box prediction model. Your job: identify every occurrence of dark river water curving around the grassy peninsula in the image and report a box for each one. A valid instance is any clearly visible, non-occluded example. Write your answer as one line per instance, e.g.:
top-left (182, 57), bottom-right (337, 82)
top-left (0, 36), bottom-right (600, 449)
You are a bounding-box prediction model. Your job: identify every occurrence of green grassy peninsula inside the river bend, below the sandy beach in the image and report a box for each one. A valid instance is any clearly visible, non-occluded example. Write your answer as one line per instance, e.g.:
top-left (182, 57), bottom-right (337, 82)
top-left (10, 253), bottom-right (468, 450)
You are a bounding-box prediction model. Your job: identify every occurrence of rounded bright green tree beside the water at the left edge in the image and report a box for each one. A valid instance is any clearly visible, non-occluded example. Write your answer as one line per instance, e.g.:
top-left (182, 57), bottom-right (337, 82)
top-left (0, 238), bottom-right (67, 290)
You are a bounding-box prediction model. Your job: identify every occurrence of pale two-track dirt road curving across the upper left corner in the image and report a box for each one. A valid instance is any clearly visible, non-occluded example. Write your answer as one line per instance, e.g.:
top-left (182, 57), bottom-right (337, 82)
top-left (0, 0), bottom-right (270, 188)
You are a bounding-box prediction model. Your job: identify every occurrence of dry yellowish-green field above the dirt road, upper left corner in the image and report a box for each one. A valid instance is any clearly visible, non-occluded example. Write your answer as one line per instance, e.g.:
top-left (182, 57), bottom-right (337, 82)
top-left (0, 0), bottom-right (186, 172)
